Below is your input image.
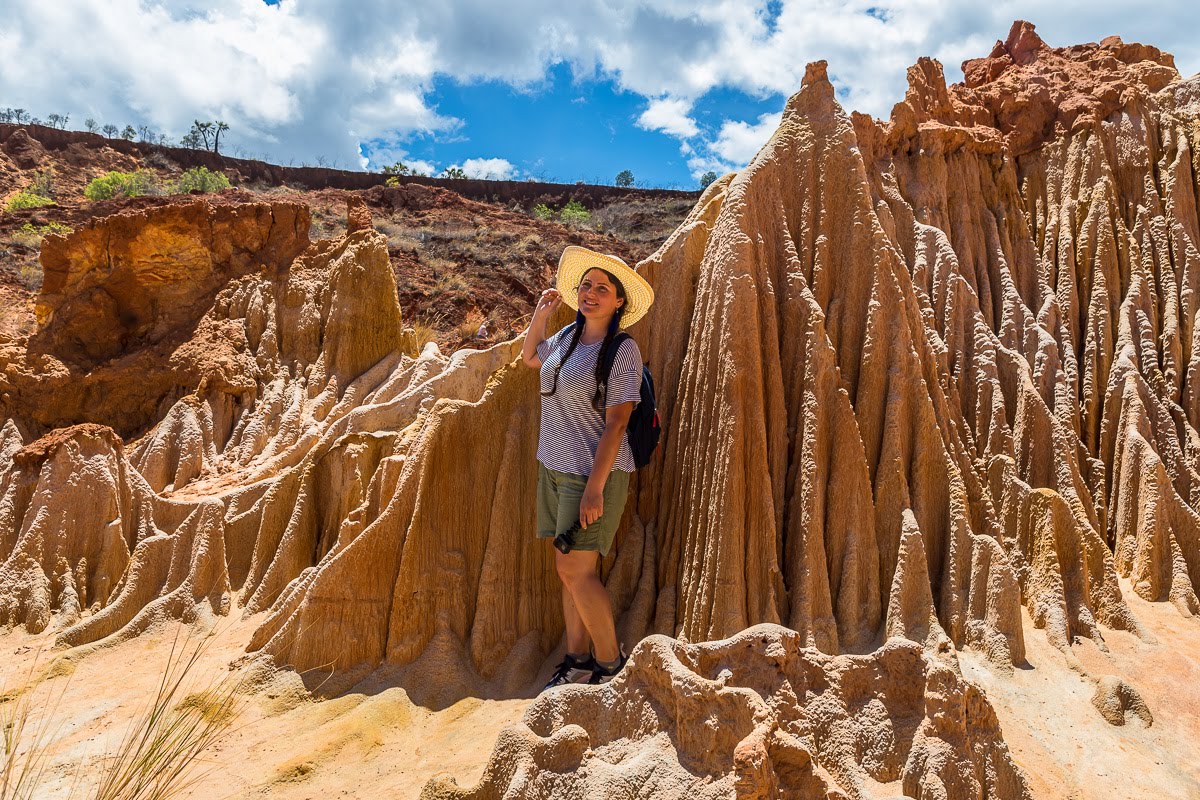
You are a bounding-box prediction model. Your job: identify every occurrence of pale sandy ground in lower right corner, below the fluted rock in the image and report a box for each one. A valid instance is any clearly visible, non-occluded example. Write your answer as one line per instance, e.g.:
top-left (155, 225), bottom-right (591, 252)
top-left (960, 581), bottom-right (1200, 800)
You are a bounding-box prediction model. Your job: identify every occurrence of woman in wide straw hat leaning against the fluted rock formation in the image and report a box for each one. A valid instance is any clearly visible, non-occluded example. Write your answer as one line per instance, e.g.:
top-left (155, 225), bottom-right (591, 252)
top-left (522, 246), bottom-right (654, 688)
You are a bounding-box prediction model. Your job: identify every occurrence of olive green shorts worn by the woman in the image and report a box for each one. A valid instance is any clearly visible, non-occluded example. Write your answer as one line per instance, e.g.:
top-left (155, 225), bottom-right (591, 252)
top-left (538, 462), bottom-right (629, 555)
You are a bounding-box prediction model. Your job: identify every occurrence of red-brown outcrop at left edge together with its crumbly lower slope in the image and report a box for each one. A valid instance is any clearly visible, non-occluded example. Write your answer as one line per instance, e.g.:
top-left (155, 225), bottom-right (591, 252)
top-left (0, 194), bottom-right (310, 437)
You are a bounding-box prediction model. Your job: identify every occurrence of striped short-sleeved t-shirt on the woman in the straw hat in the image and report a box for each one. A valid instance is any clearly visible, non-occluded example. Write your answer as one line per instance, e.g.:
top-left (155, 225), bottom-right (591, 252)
top-left (538, 326), bottom-right (642, 475)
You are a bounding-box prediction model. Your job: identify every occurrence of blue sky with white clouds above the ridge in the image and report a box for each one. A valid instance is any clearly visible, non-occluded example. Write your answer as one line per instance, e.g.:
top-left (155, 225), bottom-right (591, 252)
top-left (0, 0), bottom-right (1200, 188)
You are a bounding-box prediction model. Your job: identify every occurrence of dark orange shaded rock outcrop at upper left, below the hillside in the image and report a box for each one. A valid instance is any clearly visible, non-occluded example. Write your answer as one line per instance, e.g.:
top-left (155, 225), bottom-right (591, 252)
top-left (37, 199), bottom-right (310, 367)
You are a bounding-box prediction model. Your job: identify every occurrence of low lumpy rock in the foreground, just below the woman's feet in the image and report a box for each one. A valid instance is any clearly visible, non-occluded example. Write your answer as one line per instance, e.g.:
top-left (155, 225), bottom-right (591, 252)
top-left (421, 625), bottom-right (1030, 800)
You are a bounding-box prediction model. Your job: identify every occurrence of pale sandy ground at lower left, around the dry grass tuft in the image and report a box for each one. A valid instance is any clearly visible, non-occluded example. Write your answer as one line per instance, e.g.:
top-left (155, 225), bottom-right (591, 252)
top-left (0, 619), bottom-right (529, 800)
